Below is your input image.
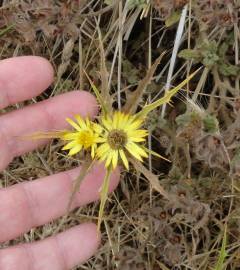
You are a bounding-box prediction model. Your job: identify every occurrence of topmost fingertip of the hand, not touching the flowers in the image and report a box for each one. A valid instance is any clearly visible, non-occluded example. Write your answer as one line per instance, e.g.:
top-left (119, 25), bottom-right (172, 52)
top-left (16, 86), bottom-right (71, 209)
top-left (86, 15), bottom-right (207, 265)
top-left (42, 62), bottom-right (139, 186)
top-left (0, 56), bottom-right (53, 109)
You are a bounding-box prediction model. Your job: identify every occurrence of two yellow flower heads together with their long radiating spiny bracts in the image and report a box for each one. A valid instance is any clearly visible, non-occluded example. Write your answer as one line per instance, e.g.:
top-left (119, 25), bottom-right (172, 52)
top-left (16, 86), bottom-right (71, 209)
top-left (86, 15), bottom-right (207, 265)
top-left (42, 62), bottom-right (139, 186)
top-left (28, 56), bottom-right (198, 229)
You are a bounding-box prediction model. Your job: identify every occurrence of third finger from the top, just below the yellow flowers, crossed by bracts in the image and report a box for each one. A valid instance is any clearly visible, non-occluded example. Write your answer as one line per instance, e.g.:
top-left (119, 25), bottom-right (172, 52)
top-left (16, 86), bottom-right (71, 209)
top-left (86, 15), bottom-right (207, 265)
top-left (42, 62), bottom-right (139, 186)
top-left (0, 164), bottom-right (119, 242)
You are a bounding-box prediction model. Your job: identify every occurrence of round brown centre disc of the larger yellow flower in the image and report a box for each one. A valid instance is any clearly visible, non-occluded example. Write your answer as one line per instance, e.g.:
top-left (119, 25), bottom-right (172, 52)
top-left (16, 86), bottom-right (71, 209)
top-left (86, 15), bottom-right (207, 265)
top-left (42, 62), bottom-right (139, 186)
top-left (107, 129), bottom-right (127, 150)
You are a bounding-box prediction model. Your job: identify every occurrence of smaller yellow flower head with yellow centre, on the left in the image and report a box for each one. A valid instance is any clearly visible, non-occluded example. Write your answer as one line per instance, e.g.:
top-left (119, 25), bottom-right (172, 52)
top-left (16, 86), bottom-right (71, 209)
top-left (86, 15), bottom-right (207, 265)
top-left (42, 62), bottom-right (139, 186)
top-left (61, 115), bottom-right (102, 159)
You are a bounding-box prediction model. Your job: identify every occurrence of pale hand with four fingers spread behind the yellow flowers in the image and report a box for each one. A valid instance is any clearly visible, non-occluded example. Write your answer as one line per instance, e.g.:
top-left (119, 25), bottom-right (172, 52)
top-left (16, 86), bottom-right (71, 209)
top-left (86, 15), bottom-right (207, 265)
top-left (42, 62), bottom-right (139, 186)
top-left (0, 56), bottom-right (119, 270)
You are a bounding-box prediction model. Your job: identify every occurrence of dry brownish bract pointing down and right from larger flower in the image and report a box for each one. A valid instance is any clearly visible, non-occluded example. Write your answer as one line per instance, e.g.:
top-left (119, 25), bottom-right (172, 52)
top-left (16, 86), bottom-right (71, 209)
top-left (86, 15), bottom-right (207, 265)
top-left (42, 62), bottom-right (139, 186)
top-left (131, 159), bottom-right (170, 200)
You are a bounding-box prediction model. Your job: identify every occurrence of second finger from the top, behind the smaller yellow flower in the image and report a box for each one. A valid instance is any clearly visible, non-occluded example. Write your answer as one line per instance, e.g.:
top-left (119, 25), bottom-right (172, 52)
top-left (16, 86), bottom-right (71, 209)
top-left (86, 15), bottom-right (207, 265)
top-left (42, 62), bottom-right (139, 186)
top-left (0, 91), bottom-right (98, 171)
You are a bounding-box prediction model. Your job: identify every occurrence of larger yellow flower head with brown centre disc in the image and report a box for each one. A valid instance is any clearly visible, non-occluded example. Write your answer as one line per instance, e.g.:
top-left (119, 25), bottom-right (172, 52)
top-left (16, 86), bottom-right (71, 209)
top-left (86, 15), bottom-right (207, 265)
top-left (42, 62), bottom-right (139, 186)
top-left (96, 111), bottom-right (148, 170)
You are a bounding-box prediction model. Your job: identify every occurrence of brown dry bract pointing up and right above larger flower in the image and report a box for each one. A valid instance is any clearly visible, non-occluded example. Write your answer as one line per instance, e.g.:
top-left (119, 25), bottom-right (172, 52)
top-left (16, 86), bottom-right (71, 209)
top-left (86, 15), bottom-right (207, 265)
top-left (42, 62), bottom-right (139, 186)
top-left (123, 52), bottom-right (165, 114)
